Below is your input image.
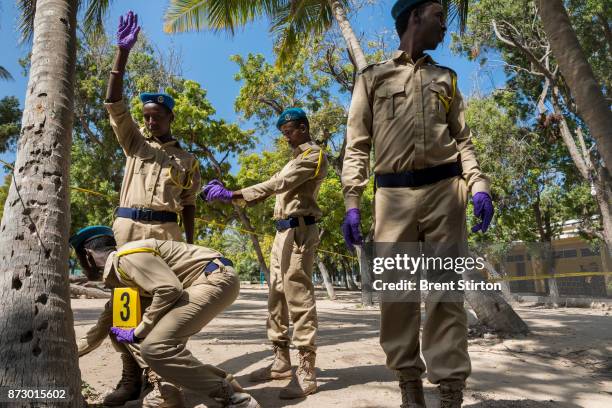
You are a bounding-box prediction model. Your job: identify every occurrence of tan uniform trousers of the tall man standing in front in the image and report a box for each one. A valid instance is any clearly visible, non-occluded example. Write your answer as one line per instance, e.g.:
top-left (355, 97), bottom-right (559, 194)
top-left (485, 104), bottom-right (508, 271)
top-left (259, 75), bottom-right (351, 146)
top-left (374, 177), bottom-right (471, 384)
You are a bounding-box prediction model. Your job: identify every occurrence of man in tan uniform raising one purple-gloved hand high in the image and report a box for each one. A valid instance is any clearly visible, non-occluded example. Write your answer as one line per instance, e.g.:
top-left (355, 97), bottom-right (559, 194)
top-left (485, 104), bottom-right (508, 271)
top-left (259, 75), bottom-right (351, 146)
top-left (78, 12), bottom-right (200, 405)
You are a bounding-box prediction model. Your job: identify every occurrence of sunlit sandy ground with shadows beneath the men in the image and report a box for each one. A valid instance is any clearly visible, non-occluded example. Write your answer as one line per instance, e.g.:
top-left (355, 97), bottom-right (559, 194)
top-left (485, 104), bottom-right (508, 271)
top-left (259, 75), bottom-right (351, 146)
top-left (72, 289), bottom-right (612, 408)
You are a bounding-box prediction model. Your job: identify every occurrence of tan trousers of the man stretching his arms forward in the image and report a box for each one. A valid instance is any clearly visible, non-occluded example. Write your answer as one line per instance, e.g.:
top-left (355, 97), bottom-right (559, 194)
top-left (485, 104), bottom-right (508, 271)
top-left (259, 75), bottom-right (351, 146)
top-left (267, 224), bottom-right (319, 351)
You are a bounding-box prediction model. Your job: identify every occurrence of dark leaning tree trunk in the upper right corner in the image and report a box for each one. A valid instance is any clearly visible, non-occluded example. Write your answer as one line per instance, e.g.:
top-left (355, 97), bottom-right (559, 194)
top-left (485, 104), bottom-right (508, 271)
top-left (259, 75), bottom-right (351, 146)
top-left (538, 0), bottom-right (612, 169)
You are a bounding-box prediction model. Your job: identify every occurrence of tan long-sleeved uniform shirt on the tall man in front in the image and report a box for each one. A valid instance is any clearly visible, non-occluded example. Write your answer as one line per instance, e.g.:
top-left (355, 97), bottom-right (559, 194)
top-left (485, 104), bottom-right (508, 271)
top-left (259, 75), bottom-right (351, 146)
top-left (342, 51), bottom-right (490, 209)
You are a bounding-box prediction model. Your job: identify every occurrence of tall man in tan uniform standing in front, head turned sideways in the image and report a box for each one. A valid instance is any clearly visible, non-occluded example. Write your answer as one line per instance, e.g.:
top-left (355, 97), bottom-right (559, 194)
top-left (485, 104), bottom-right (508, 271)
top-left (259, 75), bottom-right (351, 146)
top-left (342, 0), bottom-right (493, 408)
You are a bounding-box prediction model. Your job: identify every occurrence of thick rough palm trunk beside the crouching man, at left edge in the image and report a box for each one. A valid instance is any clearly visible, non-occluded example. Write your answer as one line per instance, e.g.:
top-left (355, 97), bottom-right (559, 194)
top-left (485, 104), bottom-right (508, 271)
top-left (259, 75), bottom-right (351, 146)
top-left (0, 0), bottom-right (84, 407)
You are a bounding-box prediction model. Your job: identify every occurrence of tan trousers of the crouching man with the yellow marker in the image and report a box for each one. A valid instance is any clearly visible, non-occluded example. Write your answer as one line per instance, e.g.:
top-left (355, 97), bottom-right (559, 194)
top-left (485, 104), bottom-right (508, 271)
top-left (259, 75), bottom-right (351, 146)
top-left (125, 266), bottom-right (240, 395)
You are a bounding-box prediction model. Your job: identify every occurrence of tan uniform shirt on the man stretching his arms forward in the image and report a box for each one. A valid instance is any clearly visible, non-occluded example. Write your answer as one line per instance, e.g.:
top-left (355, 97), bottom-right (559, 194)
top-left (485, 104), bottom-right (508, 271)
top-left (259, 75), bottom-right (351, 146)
top-left (241, 141), bottom-right (328, 220)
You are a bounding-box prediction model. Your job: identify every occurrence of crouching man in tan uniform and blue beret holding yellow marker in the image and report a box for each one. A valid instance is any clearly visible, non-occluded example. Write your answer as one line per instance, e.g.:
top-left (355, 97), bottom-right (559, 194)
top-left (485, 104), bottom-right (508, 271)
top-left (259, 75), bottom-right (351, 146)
top-left (70, 226), bottom-right (259, 408)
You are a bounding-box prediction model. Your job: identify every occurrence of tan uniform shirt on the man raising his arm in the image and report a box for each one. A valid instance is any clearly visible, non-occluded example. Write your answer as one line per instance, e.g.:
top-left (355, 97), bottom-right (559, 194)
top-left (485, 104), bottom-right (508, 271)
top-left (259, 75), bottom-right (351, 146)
top-left (104, 100), bottom-right (200, 213)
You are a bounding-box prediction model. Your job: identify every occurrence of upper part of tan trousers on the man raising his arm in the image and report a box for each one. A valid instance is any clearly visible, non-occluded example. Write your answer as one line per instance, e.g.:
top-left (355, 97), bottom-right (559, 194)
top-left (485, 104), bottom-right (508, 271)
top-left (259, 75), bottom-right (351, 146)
top-left (113, 217), bottom-right (185, 248)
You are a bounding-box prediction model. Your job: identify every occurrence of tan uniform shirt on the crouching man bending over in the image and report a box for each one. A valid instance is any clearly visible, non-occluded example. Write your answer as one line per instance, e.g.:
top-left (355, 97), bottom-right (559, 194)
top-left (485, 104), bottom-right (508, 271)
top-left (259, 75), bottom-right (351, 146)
top-left (104, 239), bottom-right (227, 338)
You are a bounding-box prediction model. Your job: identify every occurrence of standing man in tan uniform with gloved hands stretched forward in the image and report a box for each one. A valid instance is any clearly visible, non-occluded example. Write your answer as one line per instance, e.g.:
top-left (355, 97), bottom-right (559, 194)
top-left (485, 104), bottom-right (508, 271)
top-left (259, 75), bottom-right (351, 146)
top-left (203, 108), bottom-right (328, 399)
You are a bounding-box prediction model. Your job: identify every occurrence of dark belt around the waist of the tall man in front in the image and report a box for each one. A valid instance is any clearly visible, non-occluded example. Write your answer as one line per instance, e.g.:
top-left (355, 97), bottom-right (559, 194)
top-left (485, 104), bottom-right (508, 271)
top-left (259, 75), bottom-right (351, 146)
top-left (376, 162), bottom-right (463, 188)
